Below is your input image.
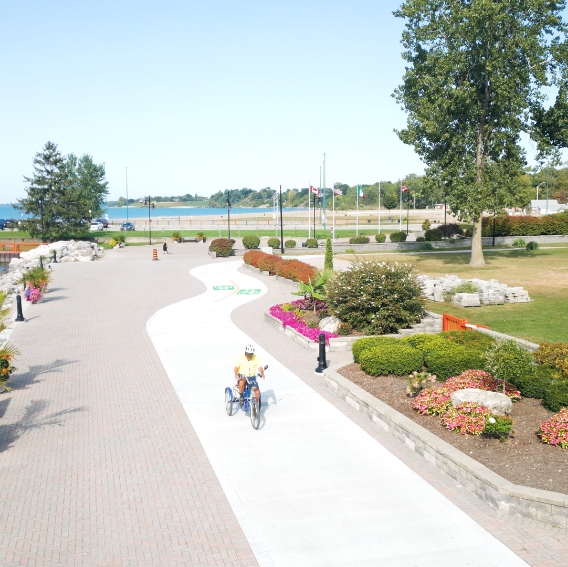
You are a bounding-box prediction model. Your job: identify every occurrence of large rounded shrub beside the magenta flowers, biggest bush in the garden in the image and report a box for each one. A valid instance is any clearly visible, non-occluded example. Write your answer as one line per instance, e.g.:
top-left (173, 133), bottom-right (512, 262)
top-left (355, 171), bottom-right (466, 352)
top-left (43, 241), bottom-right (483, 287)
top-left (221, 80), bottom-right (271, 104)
top-left (327, 260), bottom-right (424, 335)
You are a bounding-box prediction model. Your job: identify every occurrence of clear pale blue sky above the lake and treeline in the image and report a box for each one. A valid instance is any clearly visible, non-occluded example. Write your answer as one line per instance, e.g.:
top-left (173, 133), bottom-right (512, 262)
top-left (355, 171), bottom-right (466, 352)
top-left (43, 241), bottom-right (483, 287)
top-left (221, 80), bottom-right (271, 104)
top-left (0, 0), bottom-right (564, 203)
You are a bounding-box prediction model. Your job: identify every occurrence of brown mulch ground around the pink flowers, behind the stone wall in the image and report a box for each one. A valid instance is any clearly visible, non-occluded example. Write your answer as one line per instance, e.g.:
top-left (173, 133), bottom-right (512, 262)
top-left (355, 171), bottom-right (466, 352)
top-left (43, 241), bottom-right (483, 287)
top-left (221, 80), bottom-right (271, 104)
top-left (339, 364), bottom-right (568, 494)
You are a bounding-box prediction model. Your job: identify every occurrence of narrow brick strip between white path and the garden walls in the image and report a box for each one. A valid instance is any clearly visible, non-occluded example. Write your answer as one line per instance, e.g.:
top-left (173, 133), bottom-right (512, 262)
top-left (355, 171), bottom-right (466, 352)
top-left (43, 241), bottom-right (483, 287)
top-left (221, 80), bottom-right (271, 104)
top-left (232, 270), bottom-right (568, 567)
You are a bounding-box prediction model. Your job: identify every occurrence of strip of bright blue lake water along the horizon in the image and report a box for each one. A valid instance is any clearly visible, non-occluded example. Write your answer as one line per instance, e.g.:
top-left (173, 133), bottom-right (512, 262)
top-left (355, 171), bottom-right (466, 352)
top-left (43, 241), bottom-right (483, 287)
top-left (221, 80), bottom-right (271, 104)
top-left (0, 205), bottom-right (307, 220)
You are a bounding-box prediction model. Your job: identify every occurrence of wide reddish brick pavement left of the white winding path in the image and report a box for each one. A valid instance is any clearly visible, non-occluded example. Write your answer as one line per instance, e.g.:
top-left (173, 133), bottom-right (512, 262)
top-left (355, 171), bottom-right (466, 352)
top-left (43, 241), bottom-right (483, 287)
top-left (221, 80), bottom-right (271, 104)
top-left (0, 244), bottom-right (257, 567)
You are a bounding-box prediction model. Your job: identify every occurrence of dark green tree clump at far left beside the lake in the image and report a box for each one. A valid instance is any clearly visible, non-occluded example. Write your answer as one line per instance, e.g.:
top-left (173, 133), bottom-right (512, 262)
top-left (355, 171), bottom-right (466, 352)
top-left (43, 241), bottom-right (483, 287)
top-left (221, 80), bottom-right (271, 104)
top-left (16, 142), bottom-right (107, 242)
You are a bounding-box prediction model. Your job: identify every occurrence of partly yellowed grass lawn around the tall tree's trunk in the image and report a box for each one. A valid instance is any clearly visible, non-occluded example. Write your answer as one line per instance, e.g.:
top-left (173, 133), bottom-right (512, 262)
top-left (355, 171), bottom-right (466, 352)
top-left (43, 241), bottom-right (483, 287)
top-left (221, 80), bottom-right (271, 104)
top-left (338, 248), bottom-right (568, 343)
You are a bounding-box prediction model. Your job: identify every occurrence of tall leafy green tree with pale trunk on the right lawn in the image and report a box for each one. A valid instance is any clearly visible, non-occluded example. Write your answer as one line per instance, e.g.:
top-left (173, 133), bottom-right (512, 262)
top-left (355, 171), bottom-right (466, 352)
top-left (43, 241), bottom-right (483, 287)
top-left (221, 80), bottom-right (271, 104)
top-left (395, 0), bottom-right (568, 266)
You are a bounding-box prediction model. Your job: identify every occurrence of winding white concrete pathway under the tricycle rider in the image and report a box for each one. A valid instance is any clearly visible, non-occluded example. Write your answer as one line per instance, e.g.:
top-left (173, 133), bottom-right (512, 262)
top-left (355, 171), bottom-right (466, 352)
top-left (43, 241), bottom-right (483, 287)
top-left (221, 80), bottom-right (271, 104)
top-left (147, 262), bottom-right (526, 567)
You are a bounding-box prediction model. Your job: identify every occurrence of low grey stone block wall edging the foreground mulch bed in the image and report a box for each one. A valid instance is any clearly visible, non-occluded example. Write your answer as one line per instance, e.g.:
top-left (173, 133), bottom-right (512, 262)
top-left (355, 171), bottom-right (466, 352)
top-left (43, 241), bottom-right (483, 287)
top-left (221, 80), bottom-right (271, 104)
top-left (324, 364), bottom-right (568, 527)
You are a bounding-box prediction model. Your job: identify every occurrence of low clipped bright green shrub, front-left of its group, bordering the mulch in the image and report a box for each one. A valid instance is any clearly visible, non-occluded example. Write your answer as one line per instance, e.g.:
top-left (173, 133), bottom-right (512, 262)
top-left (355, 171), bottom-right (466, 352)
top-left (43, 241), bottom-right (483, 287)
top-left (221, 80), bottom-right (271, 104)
top-left (359, 344), bottom-right (423, 376)
